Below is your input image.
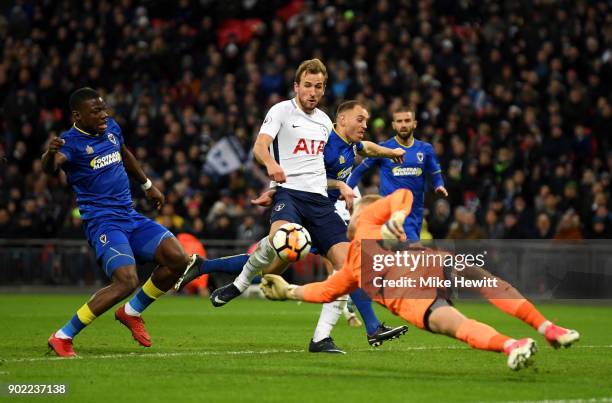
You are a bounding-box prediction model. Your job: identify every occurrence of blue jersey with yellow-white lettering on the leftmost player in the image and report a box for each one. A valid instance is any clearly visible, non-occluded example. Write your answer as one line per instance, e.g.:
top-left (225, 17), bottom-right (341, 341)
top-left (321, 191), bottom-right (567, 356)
top-left (59, 119), bottom-right (133, 220)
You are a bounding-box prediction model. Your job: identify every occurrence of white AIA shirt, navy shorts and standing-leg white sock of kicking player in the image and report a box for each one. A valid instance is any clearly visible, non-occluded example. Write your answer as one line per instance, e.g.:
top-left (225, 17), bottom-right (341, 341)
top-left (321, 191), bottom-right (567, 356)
top-left (259, 99), bottom-right (376, 352)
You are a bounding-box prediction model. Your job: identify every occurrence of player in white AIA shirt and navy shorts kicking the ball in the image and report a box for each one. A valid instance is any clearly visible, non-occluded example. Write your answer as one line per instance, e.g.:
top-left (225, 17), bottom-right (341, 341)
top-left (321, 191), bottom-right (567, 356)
top-left (211, 59), bottom-right (408, 352)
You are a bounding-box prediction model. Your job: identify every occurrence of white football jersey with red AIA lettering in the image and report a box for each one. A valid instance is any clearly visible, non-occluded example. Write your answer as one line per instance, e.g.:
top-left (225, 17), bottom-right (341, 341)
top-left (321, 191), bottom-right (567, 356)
top-left (259, 99), bottom-right (332, 196)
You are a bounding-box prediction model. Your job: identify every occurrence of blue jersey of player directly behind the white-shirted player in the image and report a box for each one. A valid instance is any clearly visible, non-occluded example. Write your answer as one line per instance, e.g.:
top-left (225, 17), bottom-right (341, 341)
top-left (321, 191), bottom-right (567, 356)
top-left (323, 129), bottom-right (363, 201)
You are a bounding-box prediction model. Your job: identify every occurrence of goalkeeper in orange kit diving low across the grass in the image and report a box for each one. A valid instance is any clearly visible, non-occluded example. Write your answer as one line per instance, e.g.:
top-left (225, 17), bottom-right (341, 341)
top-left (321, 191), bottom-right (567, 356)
top-left (261, 189), bottom-right (580, 370)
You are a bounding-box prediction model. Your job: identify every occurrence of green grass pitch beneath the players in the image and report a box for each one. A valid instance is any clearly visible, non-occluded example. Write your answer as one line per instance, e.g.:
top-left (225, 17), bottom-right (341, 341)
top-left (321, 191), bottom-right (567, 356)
top-left (0, 295), bottom-right (612, 403)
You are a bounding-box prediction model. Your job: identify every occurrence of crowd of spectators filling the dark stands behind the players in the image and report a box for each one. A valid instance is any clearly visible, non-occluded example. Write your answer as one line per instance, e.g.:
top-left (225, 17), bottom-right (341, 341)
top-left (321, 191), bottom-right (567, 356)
top-left (0, 0), bottom-right (612, 240)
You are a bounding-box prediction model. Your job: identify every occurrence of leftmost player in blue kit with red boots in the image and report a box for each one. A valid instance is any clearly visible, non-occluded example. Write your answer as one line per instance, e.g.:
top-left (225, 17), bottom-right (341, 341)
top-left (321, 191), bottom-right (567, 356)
top-left (42, 87), bottom-right (195, 357)
